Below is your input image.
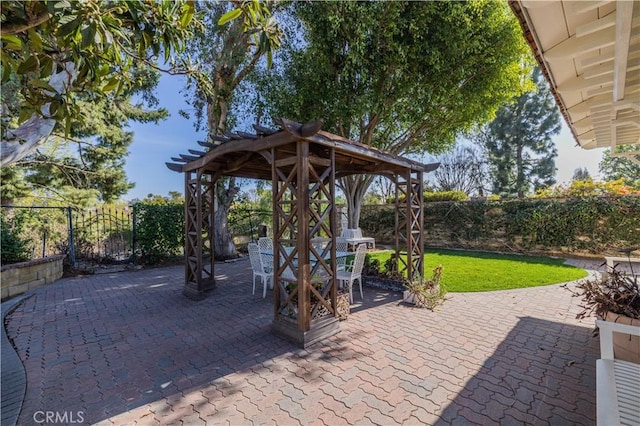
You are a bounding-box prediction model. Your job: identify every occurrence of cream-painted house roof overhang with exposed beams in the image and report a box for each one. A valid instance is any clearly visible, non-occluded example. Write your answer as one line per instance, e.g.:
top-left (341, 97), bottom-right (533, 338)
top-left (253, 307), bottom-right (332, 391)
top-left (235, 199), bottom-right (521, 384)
top-left (509, 0), bottom-right (640, 161)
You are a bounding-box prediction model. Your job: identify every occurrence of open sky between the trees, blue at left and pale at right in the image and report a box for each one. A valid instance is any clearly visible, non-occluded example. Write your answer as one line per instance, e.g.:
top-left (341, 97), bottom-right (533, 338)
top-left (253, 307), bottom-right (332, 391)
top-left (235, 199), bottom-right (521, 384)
top-left (124, 75), bottom-right (603, 201)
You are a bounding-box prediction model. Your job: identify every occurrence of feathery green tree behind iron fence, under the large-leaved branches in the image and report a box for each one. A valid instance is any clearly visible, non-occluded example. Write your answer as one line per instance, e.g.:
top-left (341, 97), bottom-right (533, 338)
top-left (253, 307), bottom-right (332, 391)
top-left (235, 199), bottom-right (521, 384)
top-left (1, 70), bottom-right (167, 205)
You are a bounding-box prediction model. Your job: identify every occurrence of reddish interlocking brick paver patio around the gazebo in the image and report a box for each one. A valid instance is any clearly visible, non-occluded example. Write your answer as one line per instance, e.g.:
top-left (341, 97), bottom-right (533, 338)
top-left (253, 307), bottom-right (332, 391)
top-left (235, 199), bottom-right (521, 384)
top-left (3, 260), bottom-right (598, 426)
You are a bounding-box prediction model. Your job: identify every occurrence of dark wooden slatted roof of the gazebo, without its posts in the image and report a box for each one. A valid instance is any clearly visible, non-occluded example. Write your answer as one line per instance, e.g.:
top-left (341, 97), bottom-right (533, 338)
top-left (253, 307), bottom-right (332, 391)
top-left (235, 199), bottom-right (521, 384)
top-left (166, 119), bottom-right (439, 180)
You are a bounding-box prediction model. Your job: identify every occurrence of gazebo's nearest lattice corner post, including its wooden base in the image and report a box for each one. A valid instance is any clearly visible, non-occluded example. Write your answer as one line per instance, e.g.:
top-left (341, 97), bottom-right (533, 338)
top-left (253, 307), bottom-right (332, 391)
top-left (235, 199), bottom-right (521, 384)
top-left (271, 140), bottom-right (340, 347)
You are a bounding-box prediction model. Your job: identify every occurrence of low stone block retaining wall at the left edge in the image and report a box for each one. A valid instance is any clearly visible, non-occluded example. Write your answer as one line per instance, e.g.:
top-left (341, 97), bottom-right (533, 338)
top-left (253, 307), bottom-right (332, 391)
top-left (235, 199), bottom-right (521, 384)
top-left (0, 254), bottom-right (66, 300)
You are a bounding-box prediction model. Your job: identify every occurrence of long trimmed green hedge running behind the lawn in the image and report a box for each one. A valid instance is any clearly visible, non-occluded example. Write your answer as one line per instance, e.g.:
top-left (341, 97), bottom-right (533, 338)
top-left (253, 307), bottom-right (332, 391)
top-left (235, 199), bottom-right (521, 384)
top-left (360, 196), bottom-right (640, 254)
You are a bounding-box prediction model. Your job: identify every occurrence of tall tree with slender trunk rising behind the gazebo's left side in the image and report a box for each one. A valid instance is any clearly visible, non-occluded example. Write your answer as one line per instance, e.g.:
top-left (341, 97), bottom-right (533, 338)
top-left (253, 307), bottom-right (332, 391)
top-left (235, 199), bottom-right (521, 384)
top-left (180, 2), bottom-right (281, 259)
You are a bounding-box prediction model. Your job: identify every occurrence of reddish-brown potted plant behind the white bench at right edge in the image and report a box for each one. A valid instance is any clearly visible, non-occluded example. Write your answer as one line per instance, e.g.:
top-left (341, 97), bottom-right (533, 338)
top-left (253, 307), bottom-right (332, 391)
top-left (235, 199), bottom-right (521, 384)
top-left (566, 267), bottom-right (640, 363)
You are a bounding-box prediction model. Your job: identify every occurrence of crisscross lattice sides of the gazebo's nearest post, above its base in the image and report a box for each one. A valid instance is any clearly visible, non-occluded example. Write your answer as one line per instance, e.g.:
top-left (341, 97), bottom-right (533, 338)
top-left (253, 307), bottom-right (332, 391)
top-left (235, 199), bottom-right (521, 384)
top-left (272, 143), bottom-right (336, 329)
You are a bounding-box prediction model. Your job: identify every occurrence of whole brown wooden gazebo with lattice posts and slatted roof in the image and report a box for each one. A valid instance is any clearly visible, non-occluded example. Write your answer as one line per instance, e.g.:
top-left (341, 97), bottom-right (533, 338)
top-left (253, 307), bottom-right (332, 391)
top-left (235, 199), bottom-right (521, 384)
top-left (167, 120), bottom-right (438, 347)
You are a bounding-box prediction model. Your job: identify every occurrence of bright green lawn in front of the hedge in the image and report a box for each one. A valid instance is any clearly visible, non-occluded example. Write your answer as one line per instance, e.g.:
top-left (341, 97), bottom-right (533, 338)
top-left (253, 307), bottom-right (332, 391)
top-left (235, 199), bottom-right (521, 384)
top-left (368, 249), bottom-right (587, 293)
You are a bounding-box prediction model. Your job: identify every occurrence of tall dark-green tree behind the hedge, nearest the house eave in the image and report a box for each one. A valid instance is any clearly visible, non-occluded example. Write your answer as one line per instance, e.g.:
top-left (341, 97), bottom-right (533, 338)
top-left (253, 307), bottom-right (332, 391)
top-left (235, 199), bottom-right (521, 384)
top-left (479, 68), bottom-right (560, 198)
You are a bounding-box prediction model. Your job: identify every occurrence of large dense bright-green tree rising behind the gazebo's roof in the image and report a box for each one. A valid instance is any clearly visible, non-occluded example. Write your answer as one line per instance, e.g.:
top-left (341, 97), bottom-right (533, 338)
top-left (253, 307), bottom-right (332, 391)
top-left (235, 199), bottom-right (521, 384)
top-left (258, 0), bottom-right (529, 227)
